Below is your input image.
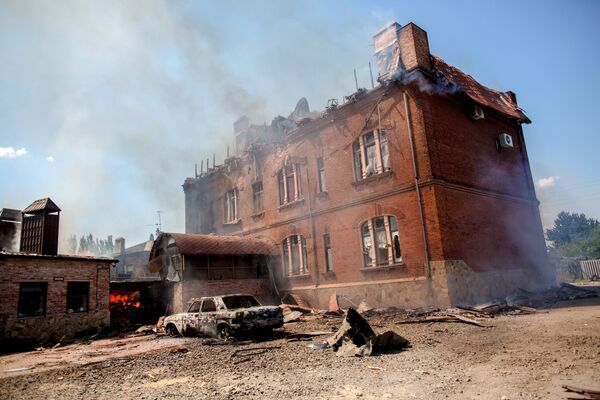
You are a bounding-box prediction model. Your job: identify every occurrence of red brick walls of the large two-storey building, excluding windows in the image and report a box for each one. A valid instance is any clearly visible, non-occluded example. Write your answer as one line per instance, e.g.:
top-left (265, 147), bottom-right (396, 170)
top-left (186, 82), bottom-right (543, 300)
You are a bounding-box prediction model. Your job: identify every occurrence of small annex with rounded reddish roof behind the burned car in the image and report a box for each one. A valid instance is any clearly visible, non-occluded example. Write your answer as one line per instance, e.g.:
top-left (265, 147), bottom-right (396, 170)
top-left (148, 233), bottom-right (279, 314)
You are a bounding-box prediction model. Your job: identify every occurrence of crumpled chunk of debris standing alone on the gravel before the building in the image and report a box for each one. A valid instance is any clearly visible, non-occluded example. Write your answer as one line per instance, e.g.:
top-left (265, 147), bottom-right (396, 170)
top-left (327, 308), bottom-right (408, 357)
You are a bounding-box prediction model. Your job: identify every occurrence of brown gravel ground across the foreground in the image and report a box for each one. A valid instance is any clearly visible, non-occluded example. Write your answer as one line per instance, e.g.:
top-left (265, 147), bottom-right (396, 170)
top-left (0, 299), bottom-right (600, 400)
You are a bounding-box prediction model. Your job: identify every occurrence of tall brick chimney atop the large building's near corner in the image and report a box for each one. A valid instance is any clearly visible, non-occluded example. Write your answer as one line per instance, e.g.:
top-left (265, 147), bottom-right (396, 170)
top-left (373, 22), bottom-right (431, 79)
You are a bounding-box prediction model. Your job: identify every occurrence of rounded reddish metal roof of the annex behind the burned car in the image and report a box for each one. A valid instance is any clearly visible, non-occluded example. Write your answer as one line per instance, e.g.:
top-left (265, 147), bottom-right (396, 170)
top-left (150, 233), bottom-right (279, 259)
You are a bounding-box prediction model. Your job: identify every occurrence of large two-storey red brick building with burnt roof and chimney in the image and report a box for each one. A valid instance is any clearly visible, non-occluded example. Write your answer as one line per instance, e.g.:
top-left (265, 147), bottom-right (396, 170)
top-left (183, 23), bottom-right (550, 307)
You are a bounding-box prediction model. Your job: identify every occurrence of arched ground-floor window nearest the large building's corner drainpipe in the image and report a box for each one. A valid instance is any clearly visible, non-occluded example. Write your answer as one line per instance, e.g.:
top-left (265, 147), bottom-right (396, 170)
top-left (360, 215), bottom-right (402, 267)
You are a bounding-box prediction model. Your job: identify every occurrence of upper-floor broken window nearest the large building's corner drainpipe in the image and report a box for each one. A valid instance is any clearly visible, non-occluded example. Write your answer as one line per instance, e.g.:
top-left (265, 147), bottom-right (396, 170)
top-left (352, 129), bottom-right (390, 181)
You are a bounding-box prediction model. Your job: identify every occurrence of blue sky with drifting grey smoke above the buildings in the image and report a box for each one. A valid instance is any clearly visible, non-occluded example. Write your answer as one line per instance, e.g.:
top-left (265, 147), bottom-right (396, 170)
top-left (0, 0), bottom-right (600, 245)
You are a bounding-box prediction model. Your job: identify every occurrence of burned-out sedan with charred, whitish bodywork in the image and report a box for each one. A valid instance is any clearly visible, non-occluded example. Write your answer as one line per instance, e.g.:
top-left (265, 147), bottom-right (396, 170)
top-left (164, 294), bottom-right (283, 338)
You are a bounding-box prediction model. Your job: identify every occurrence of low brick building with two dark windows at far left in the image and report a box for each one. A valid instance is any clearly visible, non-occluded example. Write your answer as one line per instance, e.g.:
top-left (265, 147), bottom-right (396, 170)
top-left (0, 199), bottom-right (115, 343)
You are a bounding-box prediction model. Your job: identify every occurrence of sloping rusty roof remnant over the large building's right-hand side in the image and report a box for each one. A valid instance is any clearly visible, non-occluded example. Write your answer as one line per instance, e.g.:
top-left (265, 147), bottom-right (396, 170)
top-left (431, 54), bottom-right (531, 124)
